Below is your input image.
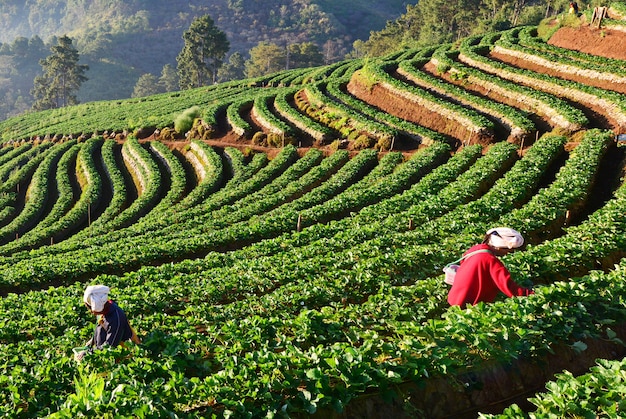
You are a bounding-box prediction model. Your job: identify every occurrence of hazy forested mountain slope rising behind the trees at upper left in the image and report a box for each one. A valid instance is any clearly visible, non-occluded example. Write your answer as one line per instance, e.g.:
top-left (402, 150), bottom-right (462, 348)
top-left (0, 0), bottom-right (406, 119)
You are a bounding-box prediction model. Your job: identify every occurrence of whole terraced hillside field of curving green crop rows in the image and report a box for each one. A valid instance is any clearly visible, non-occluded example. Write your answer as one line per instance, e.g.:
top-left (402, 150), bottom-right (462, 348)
top-left (0, 17), bottom-right (626, 418)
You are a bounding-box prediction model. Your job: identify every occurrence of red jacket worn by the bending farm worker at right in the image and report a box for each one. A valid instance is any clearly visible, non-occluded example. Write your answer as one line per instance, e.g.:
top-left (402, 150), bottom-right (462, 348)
top-left (448, 244), bottom-right (533, 306)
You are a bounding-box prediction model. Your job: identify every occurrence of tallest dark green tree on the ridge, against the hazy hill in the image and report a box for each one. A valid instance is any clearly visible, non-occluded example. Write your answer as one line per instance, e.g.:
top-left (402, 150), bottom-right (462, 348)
top-left (176, 15), bottom-right (230, 89)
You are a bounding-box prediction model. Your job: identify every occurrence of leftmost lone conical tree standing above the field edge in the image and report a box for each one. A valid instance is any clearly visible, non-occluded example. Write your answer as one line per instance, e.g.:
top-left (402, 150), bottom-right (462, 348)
top-left (31, 36), bottom-right (89, 110)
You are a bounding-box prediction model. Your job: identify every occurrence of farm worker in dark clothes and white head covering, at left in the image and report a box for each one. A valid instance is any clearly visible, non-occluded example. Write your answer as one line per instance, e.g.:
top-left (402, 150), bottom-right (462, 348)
top-left (76, 285), bottom-right (140, 361)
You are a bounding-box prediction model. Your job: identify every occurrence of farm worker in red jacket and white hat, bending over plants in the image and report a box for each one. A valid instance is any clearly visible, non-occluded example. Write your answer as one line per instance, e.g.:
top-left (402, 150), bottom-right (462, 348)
top-left (448, 227), bottom-right (533, 306)
